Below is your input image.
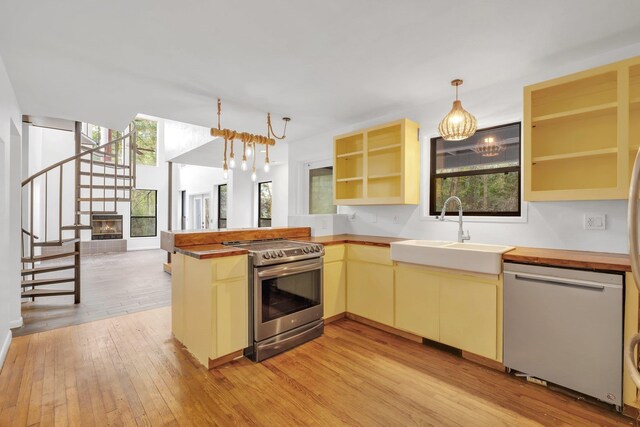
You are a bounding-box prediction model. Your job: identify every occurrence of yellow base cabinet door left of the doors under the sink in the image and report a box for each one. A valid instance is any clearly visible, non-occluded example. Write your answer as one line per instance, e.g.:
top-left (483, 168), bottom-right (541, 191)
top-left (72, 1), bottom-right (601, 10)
top-left (347, 261), bottom-right (393, 326)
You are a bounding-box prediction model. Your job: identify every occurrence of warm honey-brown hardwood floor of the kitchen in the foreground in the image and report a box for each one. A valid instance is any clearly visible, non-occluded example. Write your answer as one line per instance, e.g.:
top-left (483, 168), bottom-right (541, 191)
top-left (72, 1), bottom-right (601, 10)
top-left (0, 308), bottom-right (632, 426)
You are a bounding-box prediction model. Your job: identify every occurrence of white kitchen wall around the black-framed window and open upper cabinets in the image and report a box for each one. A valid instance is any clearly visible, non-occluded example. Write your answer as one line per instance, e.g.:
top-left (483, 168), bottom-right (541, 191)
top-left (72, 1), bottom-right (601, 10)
top-left (289, 44), bottom-right (640, 253)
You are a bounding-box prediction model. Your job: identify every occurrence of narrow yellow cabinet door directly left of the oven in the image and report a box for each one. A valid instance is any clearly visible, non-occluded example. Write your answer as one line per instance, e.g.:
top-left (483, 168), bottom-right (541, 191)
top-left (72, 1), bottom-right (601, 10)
top-left (212, 277), bottom-right (249, 359)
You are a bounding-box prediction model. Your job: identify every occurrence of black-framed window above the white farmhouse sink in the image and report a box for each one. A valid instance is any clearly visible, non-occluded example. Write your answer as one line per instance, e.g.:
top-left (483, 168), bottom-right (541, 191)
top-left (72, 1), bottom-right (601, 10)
top-left (429, 123), bottom-right (522, 216)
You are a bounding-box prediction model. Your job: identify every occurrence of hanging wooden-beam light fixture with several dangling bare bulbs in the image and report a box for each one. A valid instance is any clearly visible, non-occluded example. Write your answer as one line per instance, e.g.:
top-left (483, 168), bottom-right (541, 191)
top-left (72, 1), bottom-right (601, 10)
top-left (211, 98), bottom-right (291, 182)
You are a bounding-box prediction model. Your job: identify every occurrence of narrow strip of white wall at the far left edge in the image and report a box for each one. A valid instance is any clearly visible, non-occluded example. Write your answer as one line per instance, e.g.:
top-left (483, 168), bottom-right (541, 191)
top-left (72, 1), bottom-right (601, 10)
top-left (0, 52), bottom-right (22, 366)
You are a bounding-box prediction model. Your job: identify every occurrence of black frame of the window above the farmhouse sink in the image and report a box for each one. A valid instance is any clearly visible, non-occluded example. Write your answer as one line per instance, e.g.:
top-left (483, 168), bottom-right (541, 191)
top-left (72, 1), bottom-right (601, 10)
top-left (429, 121), bottom-right (522, 218)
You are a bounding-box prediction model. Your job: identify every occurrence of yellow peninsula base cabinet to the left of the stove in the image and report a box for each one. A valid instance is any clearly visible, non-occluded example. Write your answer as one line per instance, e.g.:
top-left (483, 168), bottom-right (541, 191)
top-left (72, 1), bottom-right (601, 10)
top-left (171, 253), bottom-right (249, 367)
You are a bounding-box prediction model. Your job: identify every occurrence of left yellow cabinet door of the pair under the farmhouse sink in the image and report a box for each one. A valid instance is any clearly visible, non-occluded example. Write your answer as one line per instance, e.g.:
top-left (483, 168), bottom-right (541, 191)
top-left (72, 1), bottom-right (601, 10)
top-left (395, 265), bottom-right (441, 341)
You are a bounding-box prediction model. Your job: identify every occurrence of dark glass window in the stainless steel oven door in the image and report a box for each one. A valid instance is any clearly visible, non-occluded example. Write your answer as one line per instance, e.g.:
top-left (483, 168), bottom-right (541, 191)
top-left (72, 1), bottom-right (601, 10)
top-left (261, 269), bottom-right (322, 323)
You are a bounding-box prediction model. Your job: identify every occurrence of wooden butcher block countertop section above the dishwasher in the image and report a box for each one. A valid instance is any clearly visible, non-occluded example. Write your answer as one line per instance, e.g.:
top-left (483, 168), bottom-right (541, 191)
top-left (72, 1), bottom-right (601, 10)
top-left (502, 247), bottom-right (631, 271)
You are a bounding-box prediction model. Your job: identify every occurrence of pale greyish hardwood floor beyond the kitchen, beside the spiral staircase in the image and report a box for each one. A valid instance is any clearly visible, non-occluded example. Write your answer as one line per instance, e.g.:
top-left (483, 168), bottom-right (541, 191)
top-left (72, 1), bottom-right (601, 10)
top-left (13, 249), bottom-right (171, 336)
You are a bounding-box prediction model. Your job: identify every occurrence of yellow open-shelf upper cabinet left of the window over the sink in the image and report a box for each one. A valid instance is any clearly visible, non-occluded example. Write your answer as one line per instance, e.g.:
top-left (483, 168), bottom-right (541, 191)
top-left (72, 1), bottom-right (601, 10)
top-left (333, 119), bottom-right (420, 205)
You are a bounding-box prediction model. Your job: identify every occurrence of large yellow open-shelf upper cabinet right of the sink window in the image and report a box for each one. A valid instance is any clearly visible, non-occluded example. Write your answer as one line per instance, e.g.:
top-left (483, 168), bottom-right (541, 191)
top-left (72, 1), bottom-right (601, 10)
top-left (524, 57), bottom-right (640, 201)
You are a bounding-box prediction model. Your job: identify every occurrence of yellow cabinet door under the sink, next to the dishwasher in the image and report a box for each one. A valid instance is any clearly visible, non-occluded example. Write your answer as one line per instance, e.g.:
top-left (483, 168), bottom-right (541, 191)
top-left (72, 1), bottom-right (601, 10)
top-left (440, 277), bottom-right (498, 360)
